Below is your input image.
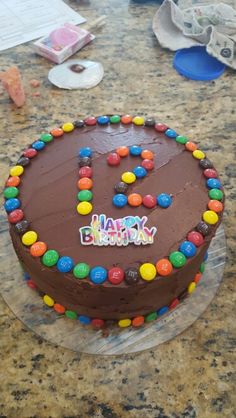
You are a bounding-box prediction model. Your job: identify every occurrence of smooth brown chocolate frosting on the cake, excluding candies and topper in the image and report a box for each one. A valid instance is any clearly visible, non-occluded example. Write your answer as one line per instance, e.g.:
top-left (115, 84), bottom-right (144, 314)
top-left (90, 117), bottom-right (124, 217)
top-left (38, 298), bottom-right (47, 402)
top-left (11, 124), bottom-right (222, 319)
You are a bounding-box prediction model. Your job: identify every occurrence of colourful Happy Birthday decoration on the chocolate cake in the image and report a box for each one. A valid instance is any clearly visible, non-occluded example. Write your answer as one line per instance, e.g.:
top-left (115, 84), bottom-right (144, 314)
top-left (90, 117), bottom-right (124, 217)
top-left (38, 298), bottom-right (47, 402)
top-left (79, 214), bottom-right (157, 247)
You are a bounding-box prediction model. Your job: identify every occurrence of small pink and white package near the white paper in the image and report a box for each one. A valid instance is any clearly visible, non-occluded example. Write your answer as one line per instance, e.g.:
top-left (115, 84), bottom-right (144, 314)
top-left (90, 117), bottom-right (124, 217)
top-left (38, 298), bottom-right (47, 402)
top-left (33, 23), bottom-right (95, 64)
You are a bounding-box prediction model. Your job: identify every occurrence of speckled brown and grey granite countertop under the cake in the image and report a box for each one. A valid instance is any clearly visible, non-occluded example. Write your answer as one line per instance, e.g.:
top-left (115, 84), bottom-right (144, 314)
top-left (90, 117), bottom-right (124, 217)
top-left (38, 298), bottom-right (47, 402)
top-left (0, 0), bottom-right (236, 418)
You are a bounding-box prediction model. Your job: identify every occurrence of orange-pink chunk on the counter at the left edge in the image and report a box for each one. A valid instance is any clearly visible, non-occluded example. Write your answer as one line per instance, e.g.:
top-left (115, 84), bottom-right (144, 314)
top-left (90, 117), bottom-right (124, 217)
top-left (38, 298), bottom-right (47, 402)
top-left (0, 67), bottom-right (25, 107)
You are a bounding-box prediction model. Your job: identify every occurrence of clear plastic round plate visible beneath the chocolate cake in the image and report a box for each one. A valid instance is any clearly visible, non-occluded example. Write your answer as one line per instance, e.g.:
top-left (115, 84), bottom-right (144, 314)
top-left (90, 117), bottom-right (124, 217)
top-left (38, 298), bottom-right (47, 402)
top-left (0, 211), bottom-right (226, 355)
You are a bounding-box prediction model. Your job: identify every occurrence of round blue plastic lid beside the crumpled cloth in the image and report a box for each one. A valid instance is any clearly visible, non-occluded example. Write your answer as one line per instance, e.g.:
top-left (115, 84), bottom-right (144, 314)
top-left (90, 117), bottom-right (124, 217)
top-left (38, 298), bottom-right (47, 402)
top-left (173, 46), bottom-right (225, 80)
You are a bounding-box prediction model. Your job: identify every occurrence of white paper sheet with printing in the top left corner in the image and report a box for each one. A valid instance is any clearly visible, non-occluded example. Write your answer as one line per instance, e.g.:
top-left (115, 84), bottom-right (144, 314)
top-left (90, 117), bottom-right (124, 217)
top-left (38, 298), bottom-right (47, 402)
top-left (0, 0), bottom-right (86, 51)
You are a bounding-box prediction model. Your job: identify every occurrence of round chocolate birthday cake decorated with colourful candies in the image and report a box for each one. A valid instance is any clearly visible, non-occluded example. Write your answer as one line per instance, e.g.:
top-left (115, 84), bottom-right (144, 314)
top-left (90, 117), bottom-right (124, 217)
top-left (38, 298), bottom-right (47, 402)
top-left (4, 115), bottom-right (224, 328)
